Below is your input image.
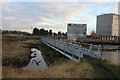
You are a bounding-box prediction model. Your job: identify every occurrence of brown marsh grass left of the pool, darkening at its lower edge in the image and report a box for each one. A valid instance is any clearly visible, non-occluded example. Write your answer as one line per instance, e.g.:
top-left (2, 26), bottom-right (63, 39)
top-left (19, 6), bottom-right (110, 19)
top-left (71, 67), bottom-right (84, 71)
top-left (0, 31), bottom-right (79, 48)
top-left (2, 37), bottom-right (37, 68)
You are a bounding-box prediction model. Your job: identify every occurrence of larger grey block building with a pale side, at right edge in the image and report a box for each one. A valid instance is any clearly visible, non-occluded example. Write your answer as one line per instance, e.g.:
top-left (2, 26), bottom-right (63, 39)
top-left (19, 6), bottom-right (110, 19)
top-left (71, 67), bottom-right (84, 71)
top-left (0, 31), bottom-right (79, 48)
top-left (96, 13), bottom-right (120, 36)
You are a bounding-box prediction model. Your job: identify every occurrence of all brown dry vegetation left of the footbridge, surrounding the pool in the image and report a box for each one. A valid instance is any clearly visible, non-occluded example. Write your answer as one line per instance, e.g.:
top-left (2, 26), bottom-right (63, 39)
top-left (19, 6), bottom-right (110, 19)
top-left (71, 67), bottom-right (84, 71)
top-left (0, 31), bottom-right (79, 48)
top-left (2, 37), bottom-right (104, 78)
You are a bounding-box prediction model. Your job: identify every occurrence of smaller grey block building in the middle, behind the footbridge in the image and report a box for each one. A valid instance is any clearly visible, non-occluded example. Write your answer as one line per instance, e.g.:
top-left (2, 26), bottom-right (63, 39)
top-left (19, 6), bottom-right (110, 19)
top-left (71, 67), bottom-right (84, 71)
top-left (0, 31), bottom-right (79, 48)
top-left (67, 24), bottom-right (87, 40)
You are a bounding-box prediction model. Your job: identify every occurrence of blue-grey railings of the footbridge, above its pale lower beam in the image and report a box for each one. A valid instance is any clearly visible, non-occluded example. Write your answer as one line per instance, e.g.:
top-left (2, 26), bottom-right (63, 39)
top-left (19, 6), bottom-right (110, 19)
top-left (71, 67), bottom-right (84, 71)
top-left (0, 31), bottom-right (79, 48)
top-left (41, 39), bottom-right (101, 58)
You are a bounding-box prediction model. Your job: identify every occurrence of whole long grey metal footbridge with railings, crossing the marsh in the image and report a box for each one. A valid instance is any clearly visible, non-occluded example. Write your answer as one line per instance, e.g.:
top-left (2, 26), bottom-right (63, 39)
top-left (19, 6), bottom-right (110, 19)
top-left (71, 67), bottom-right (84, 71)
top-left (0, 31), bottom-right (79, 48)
top-left (42, 38), bottom-right (101, 62)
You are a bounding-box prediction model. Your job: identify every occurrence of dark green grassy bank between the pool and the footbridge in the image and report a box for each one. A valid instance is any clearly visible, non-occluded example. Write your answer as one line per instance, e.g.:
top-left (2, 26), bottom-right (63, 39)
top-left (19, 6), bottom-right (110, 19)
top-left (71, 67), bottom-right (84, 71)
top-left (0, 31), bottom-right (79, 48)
top-left (38, 42), bottom-right (69, 66)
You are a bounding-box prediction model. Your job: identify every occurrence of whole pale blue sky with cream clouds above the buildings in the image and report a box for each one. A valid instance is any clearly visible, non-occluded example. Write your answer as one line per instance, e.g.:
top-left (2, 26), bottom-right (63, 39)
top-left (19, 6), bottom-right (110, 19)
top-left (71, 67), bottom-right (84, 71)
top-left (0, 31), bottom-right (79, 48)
top-left (0, 0), bottom-right (118, 34)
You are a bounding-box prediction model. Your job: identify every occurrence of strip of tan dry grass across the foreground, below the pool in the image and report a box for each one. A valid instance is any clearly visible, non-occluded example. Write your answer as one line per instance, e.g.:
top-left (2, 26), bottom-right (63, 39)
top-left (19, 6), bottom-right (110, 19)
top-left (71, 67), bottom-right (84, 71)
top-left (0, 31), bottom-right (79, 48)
top-left (3, 61), bottom-right (102, 78)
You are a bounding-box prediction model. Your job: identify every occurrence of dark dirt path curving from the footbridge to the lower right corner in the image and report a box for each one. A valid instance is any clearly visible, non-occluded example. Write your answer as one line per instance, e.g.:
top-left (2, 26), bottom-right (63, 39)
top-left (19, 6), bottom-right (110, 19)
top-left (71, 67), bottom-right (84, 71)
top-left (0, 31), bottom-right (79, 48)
top-left (85, 56), bottom-right (118, 80)
